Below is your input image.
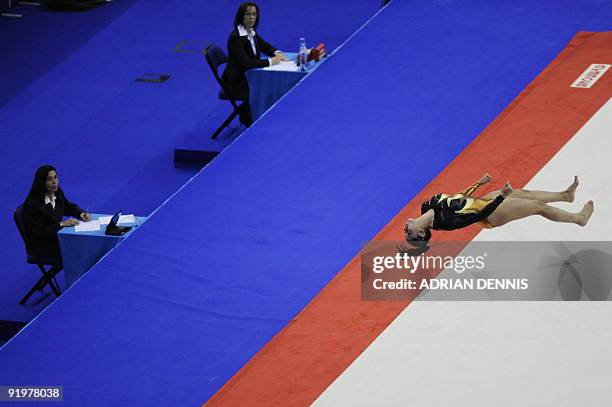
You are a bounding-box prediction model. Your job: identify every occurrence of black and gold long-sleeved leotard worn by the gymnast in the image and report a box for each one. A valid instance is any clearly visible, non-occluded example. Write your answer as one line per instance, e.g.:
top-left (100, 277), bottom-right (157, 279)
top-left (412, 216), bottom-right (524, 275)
top-left (421, 183), bottom-right (504, 230)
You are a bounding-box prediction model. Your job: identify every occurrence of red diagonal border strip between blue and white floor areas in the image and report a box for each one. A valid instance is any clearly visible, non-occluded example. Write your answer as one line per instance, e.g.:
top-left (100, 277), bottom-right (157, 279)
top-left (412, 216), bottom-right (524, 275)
top-left (206, 32), bottom-right (612, 406)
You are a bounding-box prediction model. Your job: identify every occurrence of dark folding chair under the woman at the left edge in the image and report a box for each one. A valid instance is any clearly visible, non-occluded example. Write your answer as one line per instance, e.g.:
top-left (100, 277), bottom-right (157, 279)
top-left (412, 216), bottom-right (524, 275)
top-left (13, 206), bottom-right (63, 305)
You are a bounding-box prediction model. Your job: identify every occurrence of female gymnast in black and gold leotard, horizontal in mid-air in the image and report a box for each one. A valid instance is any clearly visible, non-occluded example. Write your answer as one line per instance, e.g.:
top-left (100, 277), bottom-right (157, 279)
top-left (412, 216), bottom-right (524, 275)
top-left (400, 174), bottom-right (594, 254)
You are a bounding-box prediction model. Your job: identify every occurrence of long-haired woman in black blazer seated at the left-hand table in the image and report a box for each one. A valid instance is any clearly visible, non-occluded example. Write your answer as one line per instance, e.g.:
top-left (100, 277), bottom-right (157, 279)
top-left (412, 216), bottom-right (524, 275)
top-left (24, 165), bottom-right (91, 263)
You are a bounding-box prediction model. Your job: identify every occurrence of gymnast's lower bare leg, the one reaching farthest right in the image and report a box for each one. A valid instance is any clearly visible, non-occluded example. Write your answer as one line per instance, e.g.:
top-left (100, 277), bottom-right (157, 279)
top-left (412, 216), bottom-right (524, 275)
top-left (487, 195), bottom-right (594, 230)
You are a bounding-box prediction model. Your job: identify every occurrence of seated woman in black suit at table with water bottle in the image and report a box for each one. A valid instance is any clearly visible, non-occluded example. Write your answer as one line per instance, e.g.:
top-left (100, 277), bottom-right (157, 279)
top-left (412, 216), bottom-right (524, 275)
top-left (222, 3), bottom-right (289, 127)
